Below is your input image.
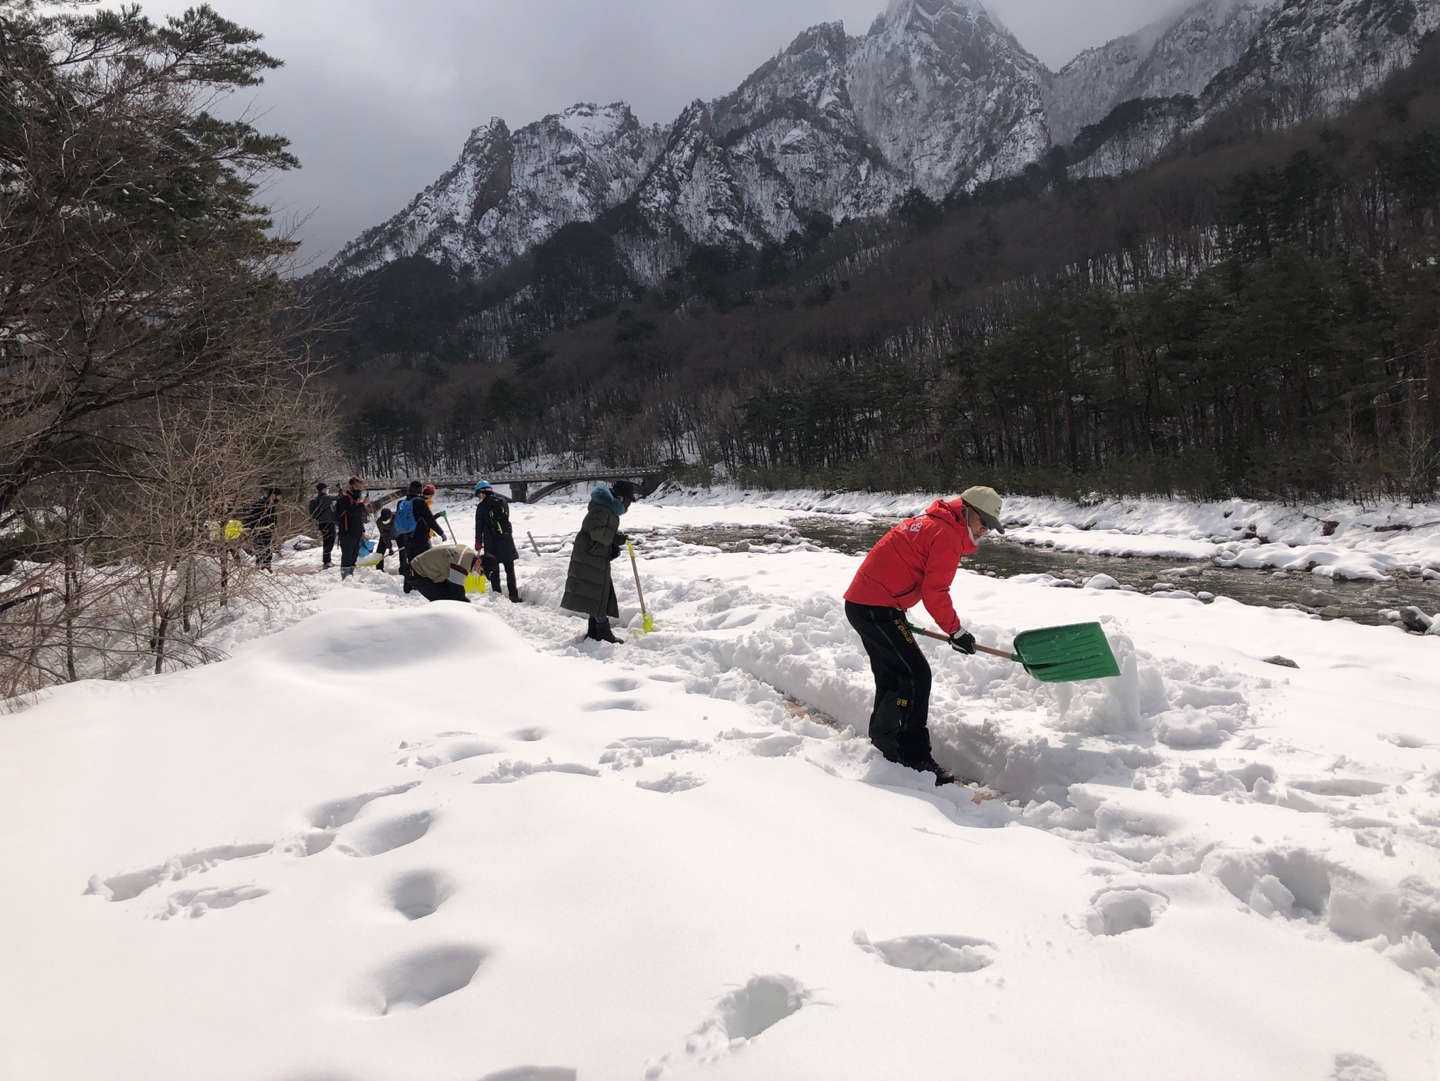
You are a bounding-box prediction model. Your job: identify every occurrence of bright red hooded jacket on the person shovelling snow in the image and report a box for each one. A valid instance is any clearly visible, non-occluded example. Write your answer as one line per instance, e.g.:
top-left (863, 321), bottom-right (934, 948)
top-left (845, 499), bottom-right (978, 635)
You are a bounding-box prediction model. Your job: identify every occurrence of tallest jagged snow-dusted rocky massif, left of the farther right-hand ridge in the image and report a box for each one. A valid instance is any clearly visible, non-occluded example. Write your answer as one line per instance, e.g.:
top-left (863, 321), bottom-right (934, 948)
top-left (331, 0), bottom-right (1050, 281)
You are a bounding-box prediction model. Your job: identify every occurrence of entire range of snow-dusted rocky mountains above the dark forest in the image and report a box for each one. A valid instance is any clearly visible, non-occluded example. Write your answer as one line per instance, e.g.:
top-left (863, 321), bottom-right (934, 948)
top-left (330, 0), bottom-right (1440, 282)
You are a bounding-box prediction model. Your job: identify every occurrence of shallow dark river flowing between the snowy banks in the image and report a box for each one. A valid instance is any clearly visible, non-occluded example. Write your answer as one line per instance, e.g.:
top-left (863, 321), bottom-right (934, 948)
top-left (674, 517), bottom-right (1440, 625)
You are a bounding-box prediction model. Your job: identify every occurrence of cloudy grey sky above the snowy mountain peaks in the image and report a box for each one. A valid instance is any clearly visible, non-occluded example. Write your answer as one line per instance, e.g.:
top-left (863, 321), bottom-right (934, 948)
top-left (141, 0), bottom-right (1178, 262)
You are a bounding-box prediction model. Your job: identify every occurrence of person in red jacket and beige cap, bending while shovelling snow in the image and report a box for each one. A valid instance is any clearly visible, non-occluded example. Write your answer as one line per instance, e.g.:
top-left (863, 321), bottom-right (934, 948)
top-left (845, 487), bottom-right (1005, 784)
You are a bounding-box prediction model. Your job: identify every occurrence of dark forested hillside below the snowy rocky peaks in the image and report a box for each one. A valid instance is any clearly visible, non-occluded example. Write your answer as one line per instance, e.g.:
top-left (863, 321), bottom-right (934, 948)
top-left (308, 39), bottom-right (1440, 499)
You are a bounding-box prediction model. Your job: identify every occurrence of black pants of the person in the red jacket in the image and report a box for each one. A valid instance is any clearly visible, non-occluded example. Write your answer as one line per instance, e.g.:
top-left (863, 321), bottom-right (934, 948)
top-left (845, 600), bottom-right (930, 764)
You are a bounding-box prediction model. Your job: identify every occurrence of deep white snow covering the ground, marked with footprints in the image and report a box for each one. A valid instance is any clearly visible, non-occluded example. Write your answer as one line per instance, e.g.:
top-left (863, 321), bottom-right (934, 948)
top-left (0, 497), bottom-right (1440, 1081)
